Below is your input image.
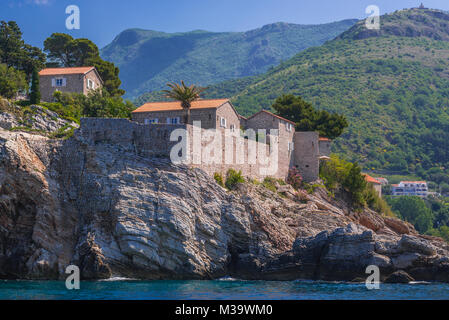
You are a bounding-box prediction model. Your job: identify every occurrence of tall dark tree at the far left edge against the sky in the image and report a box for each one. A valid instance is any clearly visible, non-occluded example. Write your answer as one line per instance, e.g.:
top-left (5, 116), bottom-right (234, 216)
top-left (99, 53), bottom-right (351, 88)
top-left (0, 21), bottom-right (46, 80)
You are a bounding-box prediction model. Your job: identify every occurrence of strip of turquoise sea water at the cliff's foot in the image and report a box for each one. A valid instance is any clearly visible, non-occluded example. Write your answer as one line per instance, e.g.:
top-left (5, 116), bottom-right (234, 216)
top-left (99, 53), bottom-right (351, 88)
top-left (0, 280), bottom-right (449, 300)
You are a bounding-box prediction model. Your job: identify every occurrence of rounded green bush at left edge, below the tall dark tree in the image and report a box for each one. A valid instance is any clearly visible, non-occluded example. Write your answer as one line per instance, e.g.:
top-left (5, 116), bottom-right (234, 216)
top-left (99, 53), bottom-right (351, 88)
top-left (0, 64), bottom-right (28, 99)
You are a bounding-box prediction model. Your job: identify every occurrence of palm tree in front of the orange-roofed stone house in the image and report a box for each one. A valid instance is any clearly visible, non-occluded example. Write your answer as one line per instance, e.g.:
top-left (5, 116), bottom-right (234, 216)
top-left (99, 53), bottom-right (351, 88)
top-left (162, 81), bottom-right (207, 123)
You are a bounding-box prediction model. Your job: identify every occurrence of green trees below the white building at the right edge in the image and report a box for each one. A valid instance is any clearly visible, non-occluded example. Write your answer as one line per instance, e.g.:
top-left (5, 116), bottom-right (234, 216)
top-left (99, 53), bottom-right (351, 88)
top-left (386, 196), bottom-right (449, 241)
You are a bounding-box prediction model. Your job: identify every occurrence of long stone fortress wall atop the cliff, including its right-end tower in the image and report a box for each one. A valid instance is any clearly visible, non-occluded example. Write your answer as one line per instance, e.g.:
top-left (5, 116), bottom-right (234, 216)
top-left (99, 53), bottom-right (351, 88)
top-left (79, 118), bottom-right (319, 181)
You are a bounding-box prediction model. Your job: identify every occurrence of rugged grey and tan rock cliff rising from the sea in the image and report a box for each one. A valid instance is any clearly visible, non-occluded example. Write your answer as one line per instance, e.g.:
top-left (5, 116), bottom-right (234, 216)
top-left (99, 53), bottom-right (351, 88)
top-left (0, 129), bottom-right (449, 281)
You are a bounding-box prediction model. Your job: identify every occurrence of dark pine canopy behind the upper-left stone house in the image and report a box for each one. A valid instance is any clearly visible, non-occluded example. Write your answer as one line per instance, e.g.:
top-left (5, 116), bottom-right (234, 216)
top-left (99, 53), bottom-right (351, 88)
top-left (44, 33), bottom-right (125, 96)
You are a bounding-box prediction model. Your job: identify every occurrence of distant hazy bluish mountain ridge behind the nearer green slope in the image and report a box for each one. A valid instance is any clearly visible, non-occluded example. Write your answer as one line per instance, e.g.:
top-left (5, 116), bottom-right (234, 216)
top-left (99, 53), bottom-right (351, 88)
top-left (101, 20), bottom-right (357, 97)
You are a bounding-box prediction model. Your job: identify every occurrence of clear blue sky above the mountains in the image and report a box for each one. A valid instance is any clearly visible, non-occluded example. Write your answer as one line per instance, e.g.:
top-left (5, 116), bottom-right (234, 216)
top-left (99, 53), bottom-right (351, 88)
top-left (0, 0), bottom-right (449, 48)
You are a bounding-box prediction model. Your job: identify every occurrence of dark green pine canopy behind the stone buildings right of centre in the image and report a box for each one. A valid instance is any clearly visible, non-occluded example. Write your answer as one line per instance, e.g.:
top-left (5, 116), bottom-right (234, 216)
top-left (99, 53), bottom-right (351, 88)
top-left (272, 94), bottom-right (348, 139)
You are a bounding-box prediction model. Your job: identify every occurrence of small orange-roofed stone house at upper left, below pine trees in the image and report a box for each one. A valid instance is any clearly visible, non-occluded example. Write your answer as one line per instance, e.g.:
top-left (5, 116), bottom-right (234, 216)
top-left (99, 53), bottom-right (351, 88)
top-left (39, 67), bottom-right (103, 102)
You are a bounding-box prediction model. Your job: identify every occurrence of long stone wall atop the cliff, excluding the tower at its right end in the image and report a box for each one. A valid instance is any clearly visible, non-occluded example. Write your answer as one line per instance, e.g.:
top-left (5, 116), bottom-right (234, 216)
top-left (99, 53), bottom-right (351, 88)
top-left (79, 118), bottom-right (280, 179)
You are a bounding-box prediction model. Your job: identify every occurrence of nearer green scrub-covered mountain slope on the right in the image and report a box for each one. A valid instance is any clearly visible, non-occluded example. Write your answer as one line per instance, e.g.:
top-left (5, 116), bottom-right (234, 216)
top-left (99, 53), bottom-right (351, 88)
top-left (150, 9), bottom-right (449, 183)
